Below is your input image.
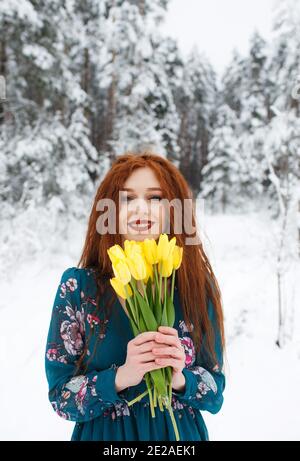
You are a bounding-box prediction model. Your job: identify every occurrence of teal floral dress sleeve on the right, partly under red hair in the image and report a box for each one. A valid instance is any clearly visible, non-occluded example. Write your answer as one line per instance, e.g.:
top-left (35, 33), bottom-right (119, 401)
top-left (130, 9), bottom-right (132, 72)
top-left (173, 300), bottom-right (225, 413)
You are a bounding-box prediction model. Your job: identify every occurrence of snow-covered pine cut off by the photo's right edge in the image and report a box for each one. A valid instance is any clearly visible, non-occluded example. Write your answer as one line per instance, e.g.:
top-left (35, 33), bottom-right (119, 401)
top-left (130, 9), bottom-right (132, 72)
top-left (264, 0), bottom-right (300, 213)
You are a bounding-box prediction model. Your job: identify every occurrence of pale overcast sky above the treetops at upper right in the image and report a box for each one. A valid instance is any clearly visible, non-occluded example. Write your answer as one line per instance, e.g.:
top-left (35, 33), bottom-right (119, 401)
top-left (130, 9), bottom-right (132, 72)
top-left (161, 0), bottom-right (274, 72)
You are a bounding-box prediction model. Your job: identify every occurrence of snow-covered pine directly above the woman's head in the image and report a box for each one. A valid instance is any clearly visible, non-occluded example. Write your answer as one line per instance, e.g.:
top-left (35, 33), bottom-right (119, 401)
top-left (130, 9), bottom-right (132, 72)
top-left (97, 0), bottom-right (179, 157)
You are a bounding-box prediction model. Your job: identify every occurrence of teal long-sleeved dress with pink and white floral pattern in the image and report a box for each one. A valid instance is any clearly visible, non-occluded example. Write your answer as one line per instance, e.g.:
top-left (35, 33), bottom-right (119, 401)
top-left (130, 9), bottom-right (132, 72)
top-left (45, 267), bottom-right (225, 441)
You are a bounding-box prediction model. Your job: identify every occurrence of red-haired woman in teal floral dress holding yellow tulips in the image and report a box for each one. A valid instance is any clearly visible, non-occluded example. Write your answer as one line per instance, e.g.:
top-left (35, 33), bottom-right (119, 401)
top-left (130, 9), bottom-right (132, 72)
top-left (45, 152), bottom-right (225, 441)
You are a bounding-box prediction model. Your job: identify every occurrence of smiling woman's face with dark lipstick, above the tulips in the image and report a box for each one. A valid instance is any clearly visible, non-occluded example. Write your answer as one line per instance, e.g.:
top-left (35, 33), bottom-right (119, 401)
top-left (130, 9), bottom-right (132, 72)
top-left (119, 167), bottom-right (166, 242)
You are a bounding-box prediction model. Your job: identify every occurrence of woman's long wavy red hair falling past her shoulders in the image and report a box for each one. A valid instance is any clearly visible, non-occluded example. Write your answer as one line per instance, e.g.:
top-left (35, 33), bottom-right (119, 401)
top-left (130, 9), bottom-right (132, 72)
top-left (76, 151), bottom-right (225, 373)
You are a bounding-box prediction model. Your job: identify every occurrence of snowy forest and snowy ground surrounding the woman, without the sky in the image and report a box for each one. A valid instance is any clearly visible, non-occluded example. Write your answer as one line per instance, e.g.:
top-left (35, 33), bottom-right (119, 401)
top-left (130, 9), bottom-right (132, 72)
top-left (0, 0), bottom-right (300, 440)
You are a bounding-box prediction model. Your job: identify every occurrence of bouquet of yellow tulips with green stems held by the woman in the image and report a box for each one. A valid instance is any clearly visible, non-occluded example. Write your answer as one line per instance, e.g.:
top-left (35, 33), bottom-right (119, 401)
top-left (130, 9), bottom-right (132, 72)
top-left (108, 234), bottom-right (183, 441)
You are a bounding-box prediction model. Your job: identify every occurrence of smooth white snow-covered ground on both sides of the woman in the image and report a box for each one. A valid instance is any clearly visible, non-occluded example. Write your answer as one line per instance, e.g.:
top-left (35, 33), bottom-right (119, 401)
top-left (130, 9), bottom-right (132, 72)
top-left (0, 208), bottom-right (300, 440)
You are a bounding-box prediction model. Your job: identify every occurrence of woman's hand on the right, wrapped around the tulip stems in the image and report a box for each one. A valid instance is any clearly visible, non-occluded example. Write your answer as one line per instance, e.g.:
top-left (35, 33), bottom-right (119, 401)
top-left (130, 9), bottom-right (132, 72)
top-left (152, 326), bottom-right (185, 391)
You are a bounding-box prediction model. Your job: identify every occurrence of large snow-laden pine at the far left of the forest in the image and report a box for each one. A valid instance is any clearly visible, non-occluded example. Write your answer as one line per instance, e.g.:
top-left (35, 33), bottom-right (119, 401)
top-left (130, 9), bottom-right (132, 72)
top-left (1, 1), bottom-right (96, 217)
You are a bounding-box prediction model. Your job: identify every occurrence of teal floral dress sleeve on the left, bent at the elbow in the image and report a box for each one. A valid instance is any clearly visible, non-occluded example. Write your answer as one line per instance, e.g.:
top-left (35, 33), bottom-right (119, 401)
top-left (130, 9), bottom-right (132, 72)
top-left (45, 267), bottom-right (126, 422)
